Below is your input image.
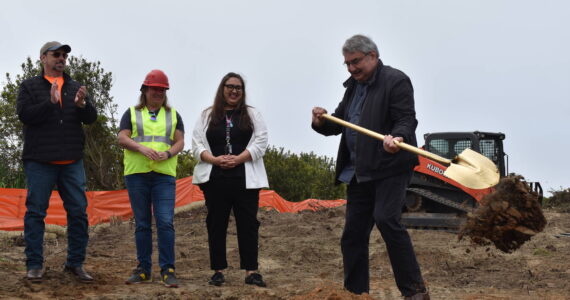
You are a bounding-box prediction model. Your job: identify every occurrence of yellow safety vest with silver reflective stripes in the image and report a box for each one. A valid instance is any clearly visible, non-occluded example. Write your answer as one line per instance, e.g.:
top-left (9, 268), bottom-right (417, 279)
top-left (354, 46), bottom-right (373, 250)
top-left (124, 106), bottom-right (178, 177)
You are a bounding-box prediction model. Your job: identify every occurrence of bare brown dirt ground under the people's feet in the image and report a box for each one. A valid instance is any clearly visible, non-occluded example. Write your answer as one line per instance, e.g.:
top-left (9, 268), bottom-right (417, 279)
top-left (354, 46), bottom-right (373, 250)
top-left (0, 206), bottom-right (570, 300)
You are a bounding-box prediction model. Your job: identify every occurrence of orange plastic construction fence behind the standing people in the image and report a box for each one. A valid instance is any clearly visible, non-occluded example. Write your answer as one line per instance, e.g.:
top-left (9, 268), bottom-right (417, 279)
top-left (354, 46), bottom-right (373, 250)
top-left (0, 177), bottom-right (346, 231)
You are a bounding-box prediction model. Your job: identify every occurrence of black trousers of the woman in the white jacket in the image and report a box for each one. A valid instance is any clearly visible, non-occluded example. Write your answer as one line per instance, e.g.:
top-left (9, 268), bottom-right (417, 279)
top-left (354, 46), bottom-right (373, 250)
top-left (200, 177), bottom-right (260, 271)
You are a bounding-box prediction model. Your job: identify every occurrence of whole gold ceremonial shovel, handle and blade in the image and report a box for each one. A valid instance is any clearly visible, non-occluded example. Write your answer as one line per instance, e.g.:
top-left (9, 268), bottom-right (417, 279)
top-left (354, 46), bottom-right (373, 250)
top-left (322, 114), bottom-right (500, 189)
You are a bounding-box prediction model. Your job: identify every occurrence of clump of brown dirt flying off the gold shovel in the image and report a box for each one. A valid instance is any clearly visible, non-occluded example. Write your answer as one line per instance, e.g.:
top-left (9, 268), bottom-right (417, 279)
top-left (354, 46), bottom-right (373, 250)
top-left (459, 175), bottom-right (546, 253)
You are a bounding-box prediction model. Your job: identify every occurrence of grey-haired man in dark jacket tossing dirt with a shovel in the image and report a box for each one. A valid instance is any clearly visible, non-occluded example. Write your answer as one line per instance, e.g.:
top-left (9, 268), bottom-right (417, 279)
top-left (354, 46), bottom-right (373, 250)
top-left (312, 35), bottom-right (429, 300)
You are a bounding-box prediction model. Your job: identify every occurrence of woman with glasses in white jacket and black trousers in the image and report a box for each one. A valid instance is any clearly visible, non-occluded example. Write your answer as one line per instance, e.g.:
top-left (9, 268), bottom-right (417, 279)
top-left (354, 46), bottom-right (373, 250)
top-left (192, 73), bottom-right (269, 287)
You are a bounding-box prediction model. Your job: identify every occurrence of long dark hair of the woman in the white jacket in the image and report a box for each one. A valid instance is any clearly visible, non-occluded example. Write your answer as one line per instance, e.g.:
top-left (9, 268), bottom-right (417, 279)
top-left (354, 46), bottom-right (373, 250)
top-left (209, 72), bottom-right (253, 130)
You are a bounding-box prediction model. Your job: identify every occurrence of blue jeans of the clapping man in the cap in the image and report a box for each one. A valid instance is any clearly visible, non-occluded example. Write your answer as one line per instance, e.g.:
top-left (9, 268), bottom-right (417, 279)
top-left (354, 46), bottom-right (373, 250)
top-left (24, 160), bottom-right (89, 270)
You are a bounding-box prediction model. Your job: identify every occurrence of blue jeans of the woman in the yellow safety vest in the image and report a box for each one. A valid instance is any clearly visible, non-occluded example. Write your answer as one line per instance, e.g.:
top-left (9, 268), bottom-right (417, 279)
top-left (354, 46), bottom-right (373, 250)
top-left (125, 172), bottom-right (176, 272)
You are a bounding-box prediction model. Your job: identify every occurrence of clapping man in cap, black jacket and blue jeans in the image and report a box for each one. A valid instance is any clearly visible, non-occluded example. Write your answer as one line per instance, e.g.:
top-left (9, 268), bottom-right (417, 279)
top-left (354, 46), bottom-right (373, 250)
top-left (16, 42), bottom-right (97, 282)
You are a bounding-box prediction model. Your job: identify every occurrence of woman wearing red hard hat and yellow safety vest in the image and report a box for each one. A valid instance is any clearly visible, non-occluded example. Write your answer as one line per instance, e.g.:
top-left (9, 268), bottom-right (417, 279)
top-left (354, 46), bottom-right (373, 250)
top-left (118, 70), bottom-right (184, 287)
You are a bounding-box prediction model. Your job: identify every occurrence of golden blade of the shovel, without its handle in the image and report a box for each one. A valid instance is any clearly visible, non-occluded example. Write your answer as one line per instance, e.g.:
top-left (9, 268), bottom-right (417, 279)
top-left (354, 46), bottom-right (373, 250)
top-left (443, 148), bottom-right (500, 189)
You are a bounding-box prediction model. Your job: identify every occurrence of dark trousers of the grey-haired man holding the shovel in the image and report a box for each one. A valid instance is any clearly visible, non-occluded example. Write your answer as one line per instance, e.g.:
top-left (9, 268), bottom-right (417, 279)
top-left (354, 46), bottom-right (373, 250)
top-left (341, 172), bottom-right (425, 296)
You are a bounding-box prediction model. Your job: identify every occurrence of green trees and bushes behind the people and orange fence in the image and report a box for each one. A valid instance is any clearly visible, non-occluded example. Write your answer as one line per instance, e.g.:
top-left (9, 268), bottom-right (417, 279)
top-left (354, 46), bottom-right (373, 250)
top-left (0, 56), bottom-right (345, 201)
